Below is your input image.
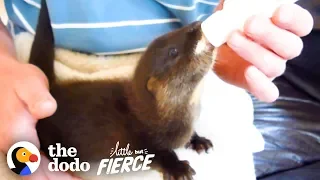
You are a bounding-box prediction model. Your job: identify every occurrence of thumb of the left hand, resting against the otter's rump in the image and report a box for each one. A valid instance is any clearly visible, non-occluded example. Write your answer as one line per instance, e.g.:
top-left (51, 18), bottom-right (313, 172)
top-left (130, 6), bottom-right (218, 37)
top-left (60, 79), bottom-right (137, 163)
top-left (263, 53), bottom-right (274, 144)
top-left (15, 76), bottom-right (57, 119)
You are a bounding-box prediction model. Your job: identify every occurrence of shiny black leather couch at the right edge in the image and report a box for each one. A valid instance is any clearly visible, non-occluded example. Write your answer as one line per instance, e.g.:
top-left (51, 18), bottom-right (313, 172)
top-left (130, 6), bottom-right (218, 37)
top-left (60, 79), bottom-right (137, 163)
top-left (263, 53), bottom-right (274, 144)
top-left (252, 30), bottom-right (320, 180)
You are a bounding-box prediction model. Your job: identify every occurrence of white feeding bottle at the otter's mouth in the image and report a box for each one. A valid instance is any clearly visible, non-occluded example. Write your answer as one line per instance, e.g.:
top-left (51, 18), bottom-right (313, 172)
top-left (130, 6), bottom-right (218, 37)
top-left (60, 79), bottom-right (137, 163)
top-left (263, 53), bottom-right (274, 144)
top-left (201, 0), bottom-right (297, 47)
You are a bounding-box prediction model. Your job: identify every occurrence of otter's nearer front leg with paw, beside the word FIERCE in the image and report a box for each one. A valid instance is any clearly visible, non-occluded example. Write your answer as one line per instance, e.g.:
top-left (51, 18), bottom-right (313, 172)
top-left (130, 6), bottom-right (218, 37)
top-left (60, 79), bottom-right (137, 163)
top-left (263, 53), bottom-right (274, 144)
top-left (152, 150), bottom-right (196, 180)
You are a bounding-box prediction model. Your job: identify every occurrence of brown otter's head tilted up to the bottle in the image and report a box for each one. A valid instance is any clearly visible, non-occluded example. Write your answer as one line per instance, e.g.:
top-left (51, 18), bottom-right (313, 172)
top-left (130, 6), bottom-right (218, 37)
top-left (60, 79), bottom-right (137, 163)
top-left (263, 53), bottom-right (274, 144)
top-left (134, 22), bottom-right (215, 119)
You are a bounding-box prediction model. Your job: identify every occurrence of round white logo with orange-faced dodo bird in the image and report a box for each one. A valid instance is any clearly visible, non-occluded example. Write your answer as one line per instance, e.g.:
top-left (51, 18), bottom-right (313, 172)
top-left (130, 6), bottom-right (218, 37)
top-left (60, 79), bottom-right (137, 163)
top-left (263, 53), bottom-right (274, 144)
top-left (7, 141), bottom-right (41, 176)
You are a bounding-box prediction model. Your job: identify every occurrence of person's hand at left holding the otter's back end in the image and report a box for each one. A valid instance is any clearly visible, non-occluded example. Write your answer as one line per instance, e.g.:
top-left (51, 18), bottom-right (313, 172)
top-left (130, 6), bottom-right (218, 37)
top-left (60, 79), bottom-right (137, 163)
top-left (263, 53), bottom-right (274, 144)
top-left (0, 57), bottom-right (78, 180)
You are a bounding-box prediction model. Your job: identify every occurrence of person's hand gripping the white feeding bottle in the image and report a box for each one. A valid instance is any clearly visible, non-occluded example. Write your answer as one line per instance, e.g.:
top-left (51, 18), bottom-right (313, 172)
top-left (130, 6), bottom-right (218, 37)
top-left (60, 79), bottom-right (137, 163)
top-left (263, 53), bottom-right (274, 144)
top-left (214, 0), bottom-right (313, 102)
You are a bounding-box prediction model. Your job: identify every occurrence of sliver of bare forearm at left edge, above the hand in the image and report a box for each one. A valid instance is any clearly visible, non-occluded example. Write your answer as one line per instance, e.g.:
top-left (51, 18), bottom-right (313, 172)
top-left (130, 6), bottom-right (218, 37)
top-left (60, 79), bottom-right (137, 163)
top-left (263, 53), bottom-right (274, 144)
top-left (0, 20), bottom-right (15, 60)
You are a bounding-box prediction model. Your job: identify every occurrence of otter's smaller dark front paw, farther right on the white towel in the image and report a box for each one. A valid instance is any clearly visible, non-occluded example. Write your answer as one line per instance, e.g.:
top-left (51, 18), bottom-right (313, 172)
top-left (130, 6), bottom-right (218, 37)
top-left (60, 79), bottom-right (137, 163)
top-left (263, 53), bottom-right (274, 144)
top-left (185, 132), bottom-right (213, 154)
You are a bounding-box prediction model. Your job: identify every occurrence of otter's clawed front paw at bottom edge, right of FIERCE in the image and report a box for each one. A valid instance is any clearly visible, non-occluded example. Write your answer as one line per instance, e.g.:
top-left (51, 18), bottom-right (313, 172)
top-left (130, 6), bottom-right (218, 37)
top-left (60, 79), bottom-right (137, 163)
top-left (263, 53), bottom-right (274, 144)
top-left (164, 161), bottom-right (196, 180)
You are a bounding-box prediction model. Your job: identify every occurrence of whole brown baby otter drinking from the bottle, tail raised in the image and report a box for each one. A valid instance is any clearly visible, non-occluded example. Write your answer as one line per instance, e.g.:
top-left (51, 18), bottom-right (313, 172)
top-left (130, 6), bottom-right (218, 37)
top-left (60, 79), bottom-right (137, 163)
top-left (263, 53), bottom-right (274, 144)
top-left (30, 0), bottom-right (214, 179)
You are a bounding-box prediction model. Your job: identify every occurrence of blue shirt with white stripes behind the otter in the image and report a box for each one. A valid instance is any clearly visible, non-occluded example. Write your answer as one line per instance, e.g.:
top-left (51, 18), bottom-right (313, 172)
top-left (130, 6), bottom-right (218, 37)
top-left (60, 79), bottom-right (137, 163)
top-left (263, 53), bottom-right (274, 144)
top-left (5, 0), bottom-right (219, 55)
